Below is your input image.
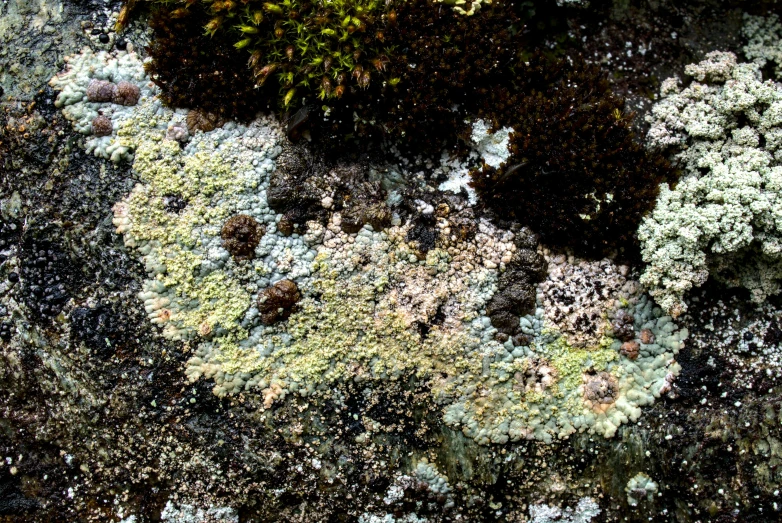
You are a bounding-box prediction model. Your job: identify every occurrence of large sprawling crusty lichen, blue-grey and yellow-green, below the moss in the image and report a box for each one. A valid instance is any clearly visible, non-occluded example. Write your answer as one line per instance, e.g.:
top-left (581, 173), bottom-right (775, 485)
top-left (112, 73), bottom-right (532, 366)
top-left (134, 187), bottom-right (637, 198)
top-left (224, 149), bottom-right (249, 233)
top-left (49, 46), bottom-right (686, 446)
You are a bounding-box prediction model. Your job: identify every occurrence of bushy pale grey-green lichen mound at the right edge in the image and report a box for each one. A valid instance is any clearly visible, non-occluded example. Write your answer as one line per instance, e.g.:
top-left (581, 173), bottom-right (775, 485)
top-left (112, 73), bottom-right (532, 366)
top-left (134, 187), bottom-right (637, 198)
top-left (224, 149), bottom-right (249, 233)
top-left (638, 52), bottom-right (782, 316)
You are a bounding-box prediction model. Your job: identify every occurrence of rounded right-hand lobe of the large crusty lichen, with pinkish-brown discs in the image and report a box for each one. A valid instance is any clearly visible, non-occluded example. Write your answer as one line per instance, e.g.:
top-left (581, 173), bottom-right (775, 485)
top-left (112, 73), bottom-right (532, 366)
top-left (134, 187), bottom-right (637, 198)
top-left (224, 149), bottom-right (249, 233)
top-left (444, 251), bottom-right (688, 443)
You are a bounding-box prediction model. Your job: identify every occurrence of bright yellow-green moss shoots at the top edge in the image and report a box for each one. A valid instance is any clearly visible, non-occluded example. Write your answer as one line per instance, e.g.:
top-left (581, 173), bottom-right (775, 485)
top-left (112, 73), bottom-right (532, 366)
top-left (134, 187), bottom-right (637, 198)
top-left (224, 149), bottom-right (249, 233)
top-left (154, 0), bottom-right (398, 108)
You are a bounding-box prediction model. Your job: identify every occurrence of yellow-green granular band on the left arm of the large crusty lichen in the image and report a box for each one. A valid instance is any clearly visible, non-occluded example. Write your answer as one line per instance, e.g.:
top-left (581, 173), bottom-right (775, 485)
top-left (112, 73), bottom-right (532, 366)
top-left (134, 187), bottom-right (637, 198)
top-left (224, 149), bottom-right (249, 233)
top-left (120, 104), bottom-right (258, 340)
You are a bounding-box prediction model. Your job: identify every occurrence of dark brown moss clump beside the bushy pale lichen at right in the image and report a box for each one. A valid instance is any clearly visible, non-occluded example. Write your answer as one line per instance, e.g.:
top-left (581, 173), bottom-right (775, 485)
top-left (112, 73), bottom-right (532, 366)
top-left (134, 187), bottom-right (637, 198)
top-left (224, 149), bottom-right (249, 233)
top-left (473, 56), bottom-right (674, 255)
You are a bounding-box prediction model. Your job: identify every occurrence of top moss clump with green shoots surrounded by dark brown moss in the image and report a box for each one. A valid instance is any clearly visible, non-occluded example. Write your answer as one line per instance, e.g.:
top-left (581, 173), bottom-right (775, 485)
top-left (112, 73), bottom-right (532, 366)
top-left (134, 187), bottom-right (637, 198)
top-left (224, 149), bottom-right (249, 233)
top-left (147, 0), bottom-right (523, 151)
